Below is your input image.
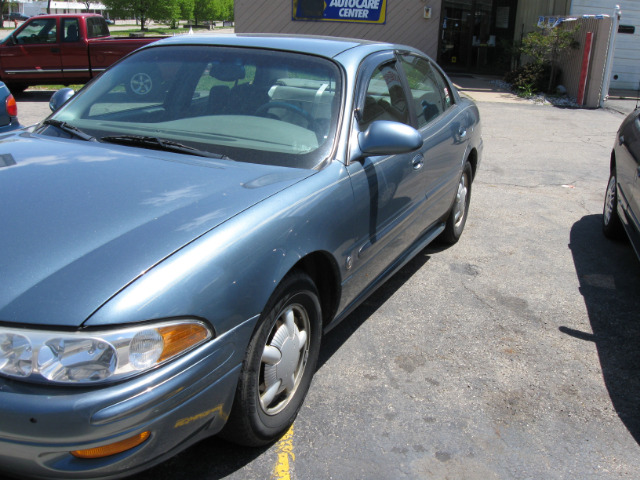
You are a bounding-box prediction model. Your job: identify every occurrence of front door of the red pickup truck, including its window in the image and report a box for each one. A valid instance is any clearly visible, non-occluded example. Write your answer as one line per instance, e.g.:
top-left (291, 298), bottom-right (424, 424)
top-left (0, 17), bottom-right (62, 83)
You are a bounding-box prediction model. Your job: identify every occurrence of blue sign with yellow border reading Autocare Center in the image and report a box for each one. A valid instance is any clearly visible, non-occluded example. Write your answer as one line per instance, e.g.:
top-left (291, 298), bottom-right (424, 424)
top-left (293, 0), bottom-right (387, 24)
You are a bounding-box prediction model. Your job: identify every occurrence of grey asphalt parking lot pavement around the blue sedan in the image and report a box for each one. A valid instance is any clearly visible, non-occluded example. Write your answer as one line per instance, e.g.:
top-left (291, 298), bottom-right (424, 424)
top-left (11, 87), bottom-right (640, 480)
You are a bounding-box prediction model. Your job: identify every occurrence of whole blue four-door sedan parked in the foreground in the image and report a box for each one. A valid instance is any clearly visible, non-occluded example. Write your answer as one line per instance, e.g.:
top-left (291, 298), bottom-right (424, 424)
top-left (0, 35), bottom-right (483, 478)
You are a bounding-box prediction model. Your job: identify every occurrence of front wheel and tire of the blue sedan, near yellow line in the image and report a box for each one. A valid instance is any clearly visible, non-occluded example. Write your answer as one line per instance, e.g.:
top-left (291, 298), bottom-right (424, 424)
top-left (221, 273), bottom-right (322, 446)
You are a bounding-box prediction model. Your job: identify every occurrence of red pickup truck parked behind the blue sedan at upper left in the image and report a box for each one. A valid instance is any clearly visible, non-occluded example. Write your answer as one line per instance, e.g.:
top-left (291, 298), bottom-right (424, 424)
top-left (0, 13), bottom-right (162, 93)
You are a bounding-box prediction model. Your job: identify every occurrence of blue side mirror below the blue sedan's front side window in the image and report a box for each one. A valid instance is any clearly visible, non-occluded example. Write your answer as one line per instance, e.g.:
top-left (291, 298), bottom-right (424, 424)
top-left (358, 120), bottom-right (423, 155)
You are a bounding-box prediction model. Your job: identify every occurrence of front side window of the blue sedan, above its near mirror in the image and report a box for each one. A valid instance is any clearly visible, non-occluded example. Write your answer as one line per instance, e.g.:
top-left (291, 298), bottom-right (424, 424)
top-left (359, 63), bottom-right (409, 131)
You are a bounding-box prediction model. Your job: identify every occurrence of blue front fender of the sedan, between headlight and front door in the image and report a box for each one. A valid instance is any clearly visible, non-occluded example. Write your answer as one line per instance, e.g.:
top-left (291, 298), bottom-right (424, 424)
top-left (84, 162), bottom-right (354, 335)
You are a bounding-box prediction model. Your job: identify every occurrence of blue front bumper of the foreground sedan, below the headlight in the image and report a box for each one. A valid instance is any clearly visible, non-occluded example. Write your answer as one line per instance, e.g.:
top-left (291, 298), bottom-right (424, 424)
top-left (0, 318), bottom-right (256, 478)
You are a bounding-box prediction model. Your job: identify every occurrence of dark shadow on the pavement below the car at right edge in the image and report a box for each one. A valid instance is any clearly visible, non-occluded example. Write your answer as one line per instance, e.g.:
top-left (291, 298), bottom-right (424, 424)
top-left (560, 215), bottom-right (640, 443)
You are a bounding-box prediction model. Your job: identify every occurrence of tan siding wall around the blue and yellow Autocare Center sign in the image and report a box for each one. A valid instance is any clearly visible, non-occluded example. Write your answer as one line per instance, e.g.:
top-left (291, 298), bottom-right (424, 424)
top-left (234, 0), bottom-right (442, 58)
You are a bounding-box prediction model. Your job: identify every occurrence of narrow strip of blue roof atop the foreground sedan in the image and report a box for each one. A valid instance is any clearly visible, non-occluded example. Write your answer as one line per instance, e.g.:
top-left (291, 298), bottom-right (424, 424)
top-left (148, 33), bottom-right (400, 58)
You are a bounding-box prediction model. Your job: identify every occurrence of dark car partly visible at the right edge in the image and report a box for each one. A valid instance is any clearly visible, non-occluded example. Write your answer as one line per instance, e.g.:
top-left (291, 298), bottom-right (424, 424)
top-left (602, 109), bottom-right (640, 259)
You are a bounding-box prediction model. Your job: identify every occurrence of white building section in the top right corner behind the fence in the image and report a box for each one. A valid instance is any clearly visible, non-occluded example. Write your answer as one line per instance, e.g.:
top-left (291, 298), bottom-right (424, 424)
top-left (571, 0), bottom-right (640, 92)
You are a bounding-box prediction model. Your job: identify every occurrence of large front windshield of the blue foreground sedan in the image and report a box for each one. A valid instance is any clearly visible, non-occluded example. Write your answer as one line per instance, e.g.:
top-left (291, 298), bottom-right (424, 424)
top-left (47, 46), bottom-right (341, 168)
